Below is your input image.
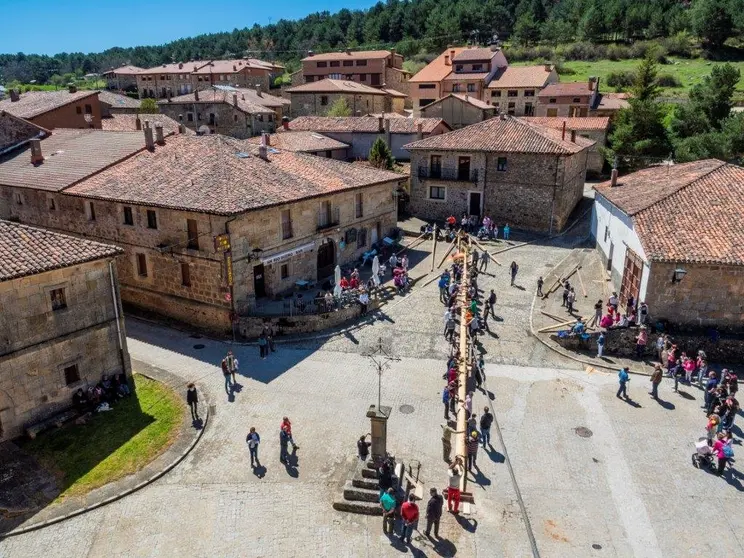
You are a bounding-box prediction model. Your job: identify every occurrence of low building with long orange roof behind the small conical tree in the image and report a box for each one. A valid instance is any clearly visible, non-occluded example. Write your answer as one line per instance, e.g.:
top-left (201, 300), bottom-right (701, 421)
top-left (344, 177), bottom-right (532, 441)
top-left (288, 114), bottom-right (451, 161)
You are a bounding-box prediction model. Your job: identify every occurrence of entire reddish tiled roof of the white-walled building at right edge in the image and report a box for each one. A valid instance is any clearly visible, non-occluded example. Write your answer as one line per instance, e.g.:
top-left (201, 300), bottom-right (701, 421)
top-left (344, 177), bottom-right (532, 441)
top-left (597, 160), bottom-right (744, 265)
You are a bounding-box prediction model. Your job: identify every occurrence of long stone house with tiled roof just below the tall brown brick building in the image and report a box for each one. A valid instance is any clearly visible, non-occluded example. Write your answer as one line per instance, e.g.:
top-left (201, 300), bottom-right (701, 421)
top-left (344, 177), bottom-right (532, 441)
top-left (286, 79), bottom-right (405, 118)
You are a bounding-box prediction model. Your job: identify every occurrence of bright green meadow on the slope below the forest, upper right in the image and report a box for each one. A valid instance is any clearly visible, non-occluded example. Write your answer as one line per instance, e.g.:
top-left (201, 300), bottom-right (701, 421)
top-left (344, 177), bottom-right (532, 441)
top-left (514, 58), bottom-right (744, 100)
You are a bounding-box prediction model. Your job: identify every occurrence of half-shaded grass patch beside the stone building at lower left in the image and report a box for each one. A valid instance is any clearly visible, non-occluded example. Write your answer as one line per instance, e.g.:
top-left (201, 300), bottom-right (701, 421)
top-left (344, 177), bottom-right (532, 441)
top-left (23, 374), bottom-right (185, 502)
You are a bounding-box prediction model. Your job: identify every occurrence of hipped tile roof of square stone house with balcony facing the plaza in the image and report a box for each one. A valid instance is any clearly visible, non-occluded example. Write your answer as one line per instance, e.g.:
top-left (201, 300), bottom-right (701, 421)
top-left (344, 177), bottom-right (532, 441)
top-left (403, 116), bottom-right (594, 155)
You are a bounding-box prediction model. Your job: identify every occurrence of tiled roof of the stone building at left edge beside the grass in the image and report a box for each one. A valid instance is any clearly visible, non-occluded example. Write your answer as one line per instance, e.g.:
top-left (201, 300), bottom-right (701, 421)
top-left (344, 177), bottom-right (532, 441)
top-left (0, 221), bottom-right (124, 282)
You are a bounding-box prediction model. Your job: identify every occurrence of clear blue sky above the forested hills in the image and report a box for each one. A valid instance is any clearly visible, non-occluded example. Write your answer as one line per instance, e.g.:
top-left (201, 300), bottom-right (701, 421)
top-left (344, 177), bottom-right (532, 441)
top-left (0, 0), bottom-right (375, 54)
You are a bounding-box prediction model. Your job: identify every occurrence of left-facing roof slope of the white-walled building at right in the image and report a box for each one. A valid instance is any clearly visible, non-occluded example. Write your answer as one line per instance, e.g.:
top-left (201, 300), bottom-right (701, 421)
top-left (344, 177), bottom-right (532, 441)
top-left (594, 159), bottom-right (725, 216)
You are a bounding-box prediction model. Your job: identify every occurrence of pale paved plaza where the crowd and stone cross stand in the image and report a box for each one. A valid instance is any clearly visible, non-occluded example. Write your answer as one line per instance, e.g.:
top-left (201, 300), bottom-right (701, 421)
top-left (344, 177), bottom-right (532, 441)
top-left (0, 234), bottom-right (744, 558)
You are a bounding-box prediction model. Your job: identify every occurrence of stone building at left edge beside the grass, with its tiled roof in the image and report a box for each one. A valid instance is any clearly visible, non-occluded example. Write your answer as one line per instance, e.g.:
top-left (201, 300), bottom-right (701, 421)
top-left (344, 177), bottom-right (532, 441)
top-left (0, 221), bottom-right (131, 442)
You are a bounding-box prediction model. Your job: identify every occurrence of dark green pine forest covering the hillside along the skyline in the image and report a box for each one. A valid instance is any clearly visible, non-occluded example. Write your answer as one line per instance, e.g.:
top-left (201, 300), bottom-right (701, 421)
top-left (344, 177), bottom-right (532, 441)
top-left (0, 0), bottom-right (744, 84)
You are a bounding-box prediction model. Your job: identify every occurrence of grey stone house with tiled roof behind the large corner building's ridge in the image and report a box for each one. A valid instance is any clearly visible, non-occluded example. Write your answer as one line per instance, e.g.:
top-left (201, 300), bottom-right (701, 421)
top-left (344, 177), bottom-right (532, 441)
top-left (158, 89), bottom-right (277, 139)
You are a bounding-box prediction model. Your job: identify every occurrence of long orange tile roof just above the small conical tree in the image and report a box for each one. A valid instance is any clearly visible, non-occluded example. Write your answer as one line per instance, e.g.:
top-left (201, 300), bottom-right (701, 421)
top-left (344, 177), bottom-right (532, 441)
top-left (289, 115), bottom-right (449, 134)
